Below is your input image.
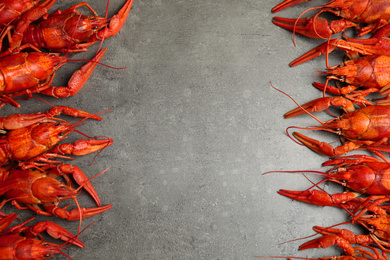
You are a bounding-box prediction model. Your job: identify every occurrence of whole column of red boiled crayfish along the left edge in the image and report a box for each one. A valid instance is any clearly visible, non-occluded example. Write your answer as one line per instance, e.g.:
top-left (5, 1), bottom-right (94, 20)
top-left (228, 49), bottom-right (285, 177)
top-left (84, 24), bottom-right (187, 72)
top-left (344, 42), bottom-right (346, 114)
top-left (0, 0), bottom-right (133, 260)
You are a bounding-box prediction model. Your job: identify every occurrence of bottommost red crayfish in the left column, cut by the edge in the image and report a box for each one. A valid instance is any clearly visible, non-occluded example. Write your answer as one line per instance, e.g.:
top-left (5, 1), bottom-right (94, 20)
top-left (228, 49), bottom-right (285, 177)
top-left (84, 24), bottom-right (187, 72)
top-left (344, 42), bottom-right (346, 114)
top-left (0, 213), bottom-right (85, 260)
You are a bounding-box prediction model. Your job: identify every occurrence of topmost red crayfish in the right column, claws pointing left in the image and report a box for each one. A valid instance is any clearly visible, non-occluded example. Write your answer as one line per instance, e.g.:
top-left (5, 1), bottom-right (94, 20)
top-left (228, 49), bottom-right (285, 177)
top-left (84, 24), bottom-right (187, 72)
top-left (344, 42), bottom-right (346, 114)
top-left (272, 0), bottom-right (390, 38)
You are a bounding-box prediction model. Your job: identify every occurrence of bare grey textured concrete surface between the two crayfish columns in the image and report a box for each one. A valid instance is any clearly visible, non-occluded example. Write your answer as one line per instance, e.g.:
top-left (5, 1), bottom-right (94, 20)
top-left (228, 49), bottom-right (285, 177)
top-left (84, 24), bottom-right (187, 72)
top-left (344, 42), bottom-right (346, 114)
top-left (2, 0), bottom-right (364, 259)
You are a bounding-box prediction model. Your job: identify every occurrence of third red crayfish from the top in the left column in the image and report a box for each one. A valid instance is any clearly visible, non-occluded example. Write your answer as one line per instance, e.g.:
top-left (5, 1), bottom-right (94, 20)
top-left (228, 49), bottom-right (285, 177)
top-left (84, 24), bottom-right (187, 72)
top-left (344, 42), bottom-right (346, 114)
top-left (0, 108), bottom-right (113, 165)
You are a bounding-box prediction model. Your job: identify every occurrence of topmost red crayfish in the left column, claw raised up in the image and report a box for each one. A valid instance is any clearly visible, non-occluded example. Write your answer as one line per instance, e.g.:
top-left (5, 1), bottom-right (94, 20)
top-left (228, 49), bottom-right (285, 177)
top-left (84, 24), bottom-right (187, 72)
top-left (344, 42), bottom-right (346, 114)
top-left (0, 0), bottom-right (133, 52)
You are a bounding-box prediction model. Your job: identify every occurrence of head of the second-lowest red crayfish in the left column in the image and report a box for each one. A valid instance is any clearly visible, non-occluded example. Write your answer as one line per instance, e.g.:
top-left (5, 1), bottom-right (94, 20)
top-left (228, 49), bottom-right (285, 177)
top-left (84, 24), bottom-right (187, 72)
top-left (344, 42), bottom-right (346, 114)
top-left (31, 177), bottom-right (77, 203)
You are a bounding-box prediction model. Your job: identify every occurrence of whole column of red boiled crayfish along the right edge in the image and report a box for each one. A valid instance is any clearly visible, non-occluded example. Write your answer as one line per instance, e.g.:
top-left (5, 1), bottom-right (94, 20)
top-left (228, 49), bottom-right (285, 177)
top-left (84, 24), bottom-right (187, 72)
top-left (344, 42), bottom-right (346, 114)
top-left (261, 0), bottom-right (390, 260)
